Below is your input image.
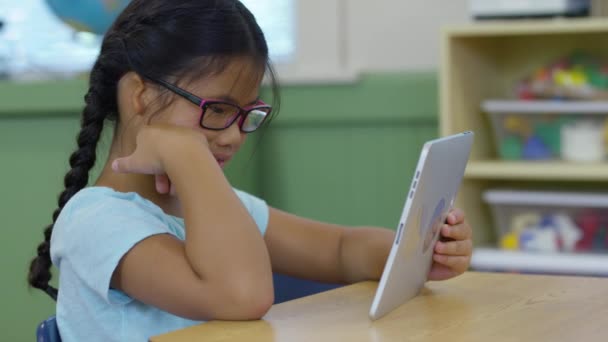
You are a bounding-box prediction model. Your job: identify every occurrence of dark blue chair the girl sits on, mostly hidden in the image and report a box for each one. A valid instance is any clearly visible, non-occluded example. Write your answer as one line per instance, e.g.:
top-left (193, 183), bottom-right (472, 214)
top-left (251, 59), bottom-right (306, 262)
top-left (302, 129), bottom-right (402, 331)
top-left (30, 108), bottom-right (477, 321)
top-left (36, 274), bottom-right (342, 342)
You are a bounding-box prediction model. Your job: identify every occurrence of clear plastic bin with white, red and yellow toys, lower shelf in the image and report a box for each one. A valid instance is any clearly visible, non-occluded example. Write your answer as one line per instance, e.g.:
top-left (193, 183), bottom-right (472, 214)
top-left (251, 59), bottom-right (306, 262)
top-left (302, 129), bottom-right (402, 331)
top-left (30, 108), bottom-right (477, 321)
top-left (483, 190), bottom-right (608, 253)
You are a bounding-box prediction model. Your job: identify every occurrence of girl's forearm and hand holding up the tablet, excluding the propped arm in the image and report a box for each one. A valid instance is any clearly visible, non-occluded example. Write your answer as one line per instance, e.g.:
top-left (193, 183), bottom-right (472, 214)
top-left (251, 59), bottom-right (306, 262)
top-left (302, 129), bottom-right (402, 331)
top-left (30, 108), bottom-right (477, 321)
top-left (264, 208), bottom-right (471, 283)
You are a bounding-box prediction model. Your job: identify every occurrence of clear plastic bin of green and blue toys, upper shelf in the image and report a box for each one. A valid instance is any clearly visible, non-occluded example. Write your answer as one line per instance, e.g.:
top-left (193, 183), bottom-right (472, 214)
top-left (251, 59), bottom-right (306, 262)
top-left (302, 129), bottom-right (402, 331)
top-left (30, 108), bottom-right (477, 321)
top-left (482, 100), bottom-right (608, 162)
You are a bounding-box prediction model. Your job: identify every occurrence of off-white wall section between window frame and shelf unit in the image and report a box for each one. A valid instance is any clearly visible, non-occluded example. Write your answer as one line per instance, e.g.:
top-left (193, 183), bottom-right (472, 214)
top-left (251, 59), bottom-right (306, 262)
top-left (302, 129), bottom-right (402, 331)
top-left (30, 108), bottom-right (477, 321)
top-left (344, 0), bottom-right (470, 71)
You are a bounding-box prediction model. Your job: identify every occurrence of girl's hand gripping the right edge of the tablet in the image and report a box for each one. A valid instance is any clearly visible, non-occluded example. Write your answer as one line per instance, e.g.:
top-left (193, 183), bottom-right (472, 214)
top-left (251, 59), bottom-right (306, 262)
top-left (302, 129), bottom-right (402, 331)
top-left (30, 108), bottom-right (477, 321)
top-left (428, 209), bottom-right (473, 280)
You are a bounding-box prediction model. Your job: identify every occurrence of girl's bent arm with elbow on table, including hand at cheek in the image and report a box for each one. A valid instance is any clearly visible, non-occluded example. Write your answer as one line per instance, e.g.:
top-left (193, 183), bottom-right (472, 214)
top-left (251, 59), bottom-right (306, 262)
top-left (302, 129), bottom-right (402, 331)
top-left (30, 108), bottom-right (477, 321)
top-left (111, 128), bottom-right (274, 320)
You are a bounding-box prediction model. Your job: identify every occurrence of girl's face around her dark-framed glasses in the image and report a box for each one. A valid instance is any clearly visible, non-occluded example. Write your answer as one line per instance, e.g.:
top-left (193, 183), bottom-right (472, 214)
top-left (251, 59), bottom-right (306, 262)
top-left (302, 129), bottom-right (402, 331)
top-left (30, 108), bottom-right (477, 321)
top-left (152, 59), bottom-right (261, 168)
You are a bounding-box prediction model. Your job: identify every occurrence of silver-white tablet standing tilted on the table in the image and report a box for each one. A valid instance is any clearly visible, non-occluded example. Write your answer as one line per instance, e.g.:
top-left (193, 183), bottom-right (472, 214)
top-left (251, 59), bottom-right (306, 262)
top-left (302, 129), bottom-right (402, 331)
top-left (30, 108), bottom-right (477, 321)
top-left (369, 132), bottom-right (473, 320)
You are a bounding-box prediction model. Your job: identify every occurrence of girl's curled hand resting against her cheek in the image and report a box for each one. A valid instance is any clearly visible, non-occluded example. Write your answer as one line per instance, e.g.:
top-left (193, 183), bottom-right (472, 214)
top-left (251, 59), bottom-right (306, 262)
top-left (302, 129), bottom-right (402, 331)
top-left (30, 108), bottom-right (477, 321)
top-left (112, 125), bottom-right (207, 176)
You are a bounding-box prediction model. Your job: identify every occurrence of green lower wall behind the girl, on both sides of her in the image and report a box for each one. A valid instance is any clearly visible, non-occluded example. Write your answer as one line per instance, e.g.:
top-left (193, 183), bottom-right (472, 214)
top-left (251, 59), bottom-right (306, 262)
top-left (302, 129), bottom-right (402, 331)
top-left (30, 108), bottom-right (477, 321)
top-left (0, 72), bottom-right (437, 341)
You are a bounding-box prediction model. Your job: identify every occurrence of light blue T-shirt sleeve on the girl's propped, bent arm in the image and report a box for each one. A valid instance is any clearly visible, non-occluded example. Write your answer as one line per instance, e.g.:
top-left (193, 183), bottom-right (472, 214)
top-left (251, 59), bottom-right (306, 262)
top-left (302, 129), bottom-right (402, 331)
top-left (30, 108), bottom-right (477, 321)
top-left (51, 192), bottom-right (170, 304)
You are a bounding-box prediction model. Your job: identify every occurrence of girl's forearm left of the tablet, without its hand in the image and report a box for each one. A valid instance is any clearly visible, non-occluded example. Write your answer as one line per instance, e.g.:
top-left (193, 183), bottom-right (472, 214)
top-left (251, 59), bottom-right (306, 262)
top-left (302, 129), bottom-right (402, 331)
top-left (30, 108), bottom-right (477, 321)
top-left (264, 208), bottom-right (394, 283)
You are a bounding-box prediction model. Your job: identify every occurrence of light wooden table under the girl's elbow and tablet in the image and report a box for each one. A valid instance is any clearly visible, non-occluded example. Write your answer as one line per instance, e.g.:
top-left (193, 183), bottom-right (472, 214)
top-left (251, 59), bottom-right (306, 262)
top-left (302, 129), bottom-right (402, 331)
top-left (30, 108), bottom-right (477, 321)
top-left (151, 272), bottom-right (608, 342)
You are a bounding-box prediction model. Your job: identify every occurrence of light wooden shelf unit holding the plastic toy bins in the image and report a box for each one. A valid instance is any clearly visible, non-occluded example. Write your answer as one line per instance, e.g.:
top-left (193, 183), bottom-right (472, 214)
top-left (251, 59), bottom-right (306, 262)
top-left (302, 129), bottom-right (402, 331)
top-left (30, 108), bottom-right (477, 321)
top-left (439, 18), bottom-right (608, 247)
